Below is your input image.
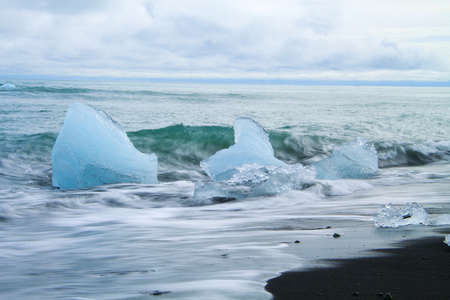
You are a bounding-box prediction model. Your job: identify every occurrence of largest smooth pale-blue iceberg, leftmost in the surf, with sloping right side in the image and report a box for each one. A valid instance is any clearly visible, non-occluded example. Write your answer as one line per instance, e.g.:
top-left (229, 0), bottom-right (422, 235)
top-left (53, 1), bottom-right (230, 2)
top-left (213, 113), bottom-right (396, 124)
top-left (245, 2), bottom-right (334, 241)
top-left (52, 102), bottom-right (158, 189)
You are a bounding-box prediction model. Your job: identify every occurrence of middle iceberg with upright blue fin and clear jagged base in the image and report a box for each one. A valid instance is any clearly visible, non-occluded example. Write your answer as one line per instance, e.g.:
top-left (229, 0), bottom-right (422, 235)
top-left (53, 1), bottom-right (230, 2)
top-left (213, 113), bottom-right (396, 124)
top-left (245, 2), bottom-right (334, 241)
top-left (193, 117), bottom-right (311, 204)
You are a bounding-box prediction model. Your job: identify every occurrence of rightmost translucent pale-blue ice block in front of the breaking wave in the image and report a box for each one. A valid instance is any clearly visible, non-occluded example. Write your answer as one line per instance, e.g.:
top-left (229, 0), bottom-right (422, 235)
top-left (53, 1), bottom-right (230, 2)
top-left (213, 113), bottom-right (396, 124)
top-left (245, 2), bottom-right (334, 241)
top-left (313, 137), bottom-right (378, 180)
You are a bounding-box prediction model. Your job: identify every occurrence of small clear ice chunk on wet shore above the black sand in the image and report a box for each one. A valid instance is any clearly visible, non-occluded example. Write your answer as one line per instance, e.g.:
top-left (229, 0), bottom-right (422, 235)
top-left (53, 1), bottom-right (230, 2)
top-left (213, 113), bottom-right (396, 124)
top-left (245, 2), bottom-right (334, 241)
top-left (374, 202), bottom-right (427, 227)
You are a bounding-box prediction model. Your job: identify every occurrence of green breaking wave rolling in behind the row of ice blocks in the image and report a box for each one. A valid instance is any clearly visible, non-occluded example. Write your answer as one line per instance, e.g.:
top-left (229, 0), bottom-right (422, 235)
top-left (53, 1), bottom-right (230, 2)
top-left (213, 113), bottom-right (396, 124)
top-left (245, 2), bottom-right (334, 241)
top-left (0, 124), bottom-right (450, 181)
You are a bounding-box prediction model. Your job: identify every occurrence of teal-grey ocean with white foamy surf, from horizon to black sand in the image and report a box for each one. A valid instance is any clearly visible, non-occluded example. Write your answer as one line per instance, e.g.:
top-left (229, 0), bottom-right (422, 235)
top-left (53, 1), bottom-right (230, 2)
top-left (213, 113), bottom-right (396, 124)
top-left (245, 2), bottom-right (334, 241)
top-left (0, 80), bottom-right (450, 299)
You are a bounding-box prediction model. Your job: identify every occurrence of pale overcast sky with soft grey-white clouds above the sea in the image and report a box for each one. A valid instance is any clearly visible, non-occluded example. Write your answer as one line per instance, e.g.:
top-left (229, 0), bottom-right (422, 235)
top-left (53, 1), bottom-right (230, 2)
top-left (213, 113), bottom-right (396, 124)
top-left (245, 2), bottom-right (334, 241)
top-left (0, 0), bottom-right (450, 81)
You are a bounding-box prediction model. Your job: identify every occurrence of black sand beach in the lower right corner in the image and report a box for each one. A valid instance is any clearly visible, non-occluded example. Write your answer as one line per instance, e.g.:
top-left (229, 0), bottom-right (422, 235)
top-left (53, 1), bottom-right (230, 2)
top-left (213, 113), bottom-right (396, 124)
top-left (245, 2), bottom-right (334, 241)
top-left (266, 235), bottom-right (450, 300)
